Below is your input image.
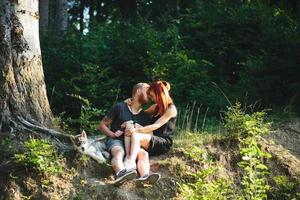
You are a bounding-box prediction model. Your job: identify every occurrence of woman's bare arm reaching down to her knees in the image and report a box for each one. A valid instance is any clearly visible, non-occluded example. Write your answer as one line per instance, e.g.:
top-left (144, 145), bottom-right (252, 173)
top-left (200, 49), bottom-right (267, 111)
top-left (132, 106), bottom-right (177, 133)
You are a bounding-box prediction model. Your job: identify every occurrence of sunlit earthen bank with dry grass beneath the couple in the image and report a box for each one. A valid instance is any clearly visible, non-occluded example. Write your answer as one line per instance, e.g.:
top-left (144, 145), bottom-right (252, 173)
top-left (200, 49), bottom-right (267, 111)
top-left (0, 119), bottom-right (300, 200)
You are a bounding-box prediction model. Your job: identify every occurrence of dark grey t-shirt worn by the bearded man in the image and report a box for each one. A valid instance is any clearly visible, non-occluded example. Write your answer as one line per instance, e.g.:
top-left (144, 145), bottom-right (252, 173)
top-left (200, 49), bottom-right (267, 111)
top-left (107, 102), bottom-right (151, 140)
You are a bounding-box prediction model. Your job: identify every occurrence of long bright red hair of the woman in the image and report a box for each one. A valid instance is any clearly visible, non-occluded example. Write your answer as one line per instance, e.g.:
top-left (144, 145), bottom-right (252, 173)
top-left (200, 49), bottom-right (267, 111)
top-left (148, 81), bottom-right (173, 115)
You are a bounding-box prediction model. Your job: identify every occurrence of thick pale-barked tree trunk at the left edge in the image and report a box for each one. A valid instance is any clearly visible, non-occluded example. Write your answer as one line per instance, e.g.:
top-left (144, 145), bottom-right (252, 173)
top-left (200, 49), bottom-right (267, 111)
top-left (0, 0), bottom-right (52, 131)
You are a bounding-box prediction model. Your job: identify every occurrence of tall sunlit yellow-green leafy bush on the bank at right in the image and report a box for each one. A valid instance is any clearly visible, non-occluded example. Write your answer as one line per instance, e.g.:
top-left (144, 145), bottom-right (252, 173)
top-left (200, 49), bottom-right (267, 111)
top-left (224, 103), bottom-right (271, 200)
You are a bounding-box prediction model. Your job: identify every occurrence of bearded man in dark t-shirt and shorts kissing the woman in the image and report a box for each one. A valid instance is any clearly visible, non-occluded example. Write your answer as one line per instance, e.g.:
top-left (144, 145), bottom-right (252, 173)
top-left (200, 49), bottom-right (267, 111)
top-left (99, 83), bottom-right (150, 184)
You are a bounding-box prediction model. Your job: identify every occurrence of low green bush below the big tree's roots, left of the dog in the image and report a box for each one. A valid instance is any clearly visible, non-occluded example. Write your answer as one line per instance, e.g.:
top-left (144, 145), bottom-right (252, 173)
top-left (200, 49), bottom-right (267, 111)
top-left (15, 139), bottom-right (62, 175)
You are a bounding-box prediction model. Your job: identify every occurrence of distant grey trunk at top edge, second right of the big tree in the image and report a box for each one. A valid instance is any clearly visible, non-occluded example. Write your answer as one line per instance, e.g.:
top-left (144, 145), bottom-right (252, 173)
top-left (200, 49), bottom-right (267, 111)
top-left (57, 0), bottom-right (68, 31)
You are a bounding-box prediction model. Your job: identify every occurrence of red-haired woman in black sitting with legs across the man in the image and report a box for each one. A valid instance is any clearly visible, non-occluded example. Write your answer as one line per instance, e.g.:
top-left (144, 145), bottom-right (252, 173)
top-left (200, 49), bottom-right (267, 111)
top-left (124, 81), bottom-right (177, 177)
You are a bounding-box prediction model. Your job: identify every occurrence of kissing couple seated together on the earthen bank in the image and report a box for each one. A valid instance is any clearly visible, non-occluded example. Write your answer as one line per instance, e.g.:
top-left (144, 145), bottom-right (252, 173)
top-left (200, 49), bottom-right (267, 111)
top-left (99, 81), bottom-right (177, 184)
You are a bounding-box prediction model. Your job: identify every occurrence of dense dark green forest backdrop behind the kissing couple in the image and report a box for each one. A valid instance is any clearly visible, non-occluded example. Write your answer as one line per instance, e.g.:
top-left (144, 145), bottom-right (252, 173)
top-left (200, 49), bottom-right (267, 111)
top-left (40, 0), bottom-right (300, 131)
